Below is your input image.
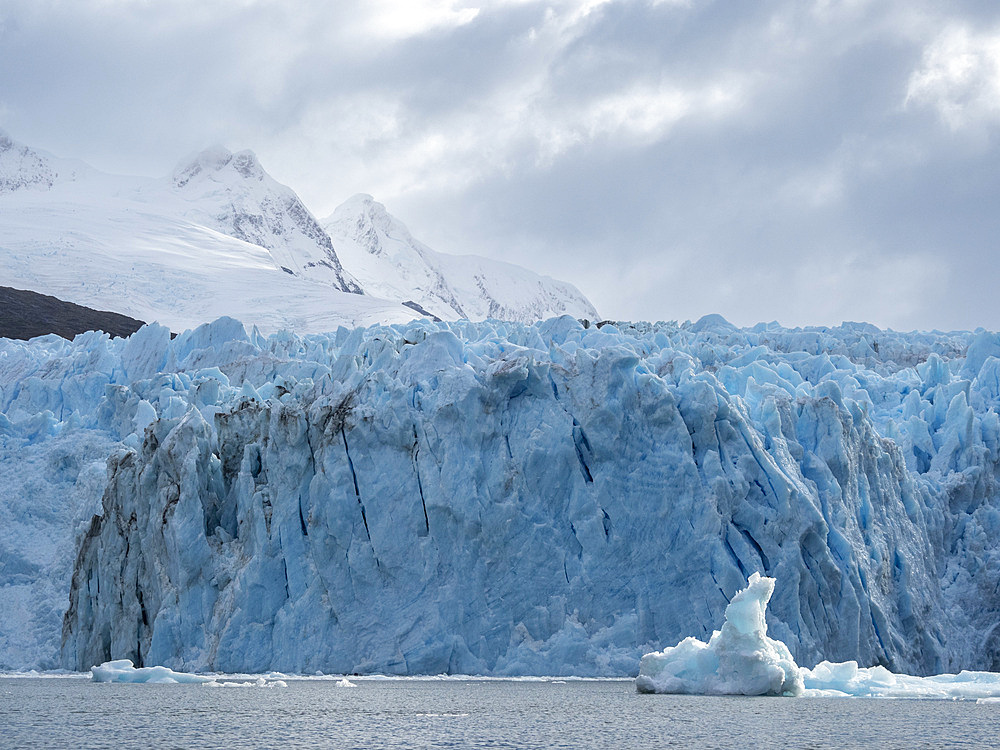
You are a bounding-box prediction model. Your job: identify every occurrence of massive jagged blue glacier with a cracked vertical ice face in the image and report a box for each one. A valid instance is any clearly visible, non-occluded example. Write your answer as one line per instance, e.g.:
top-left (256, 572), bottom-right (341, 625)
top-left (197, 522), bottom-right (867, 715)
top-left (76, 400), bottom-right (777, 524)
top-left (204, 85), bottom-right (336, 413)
top-left (0, 316), bottom-right (1000, 676)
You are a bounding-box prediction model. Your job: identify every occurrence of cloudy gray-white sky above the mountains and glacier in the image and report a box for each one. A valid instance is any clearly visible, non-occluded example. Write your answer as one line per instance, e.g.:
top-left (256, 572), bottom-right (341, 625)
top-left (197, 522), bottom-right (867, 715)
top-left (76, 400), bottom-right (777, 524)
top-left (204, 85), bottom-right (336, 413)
top-left (0, 0), bottom-right (1000, 329)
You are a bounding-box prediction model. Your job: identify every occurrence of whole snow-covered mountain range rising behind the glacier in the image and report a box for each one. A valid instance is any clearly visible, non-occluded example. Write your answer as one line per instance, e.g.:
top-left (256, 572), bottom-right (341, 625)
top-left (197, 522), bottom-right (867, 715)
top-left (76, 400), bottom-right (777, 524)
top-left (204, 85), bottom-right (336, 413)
top-left (0, 134), bottom-right (596, 333)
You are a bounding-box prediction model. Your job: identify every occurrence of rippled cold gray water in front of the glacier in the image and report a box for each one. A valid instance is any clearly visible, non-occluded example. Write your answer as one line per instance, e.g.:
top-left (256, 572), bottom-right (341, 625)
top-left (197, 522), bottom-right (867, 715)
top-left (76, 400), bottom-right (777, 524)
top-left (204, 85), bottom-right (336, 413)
top-left (0, 678), bottom-right (1000, 748)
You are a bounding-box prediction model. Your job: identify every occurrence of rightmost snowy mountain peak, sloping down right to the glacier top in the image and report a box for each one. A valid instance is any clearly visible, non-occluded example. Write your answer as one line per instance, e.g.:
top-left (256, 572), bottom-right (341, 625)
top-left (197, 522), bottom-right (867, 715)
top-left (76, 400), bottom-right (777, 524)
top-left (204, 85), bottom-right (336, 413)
top-left (323, 194), bottom-right (598, 323)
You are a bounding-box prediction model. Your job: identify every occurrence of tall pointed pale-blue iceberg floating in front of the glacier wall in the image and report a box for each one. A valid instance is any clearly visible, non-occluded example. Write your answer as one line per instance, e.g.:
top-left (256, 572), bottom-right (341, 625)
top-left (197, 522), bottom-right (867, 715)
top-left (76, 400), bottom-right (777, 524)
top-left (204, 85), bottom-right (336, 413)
top-left (636, 572), bottom-right (804, 696)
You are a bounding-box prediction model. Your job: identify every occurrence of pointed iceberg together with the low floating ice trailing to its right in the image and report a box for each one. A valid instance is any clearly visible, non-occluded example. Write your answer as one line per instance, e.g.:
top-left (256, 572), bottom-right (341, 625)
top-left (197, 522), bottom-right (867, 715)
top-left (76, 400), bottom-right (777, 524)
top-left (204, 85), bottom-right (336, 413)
top-left (635, 573), bottom-right (1000, 700)
